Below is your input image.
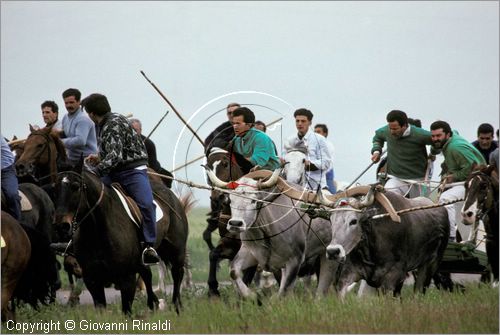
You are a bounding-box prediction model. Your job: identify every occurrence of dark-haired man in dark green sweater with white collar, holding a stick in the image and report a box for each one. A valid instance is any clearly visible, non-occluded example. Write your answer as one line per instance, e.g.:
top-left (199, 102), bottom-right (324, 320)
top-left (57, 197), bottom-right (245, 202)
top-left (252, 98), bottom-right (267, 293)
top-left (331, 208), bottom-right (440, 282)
top-left (371, 110), bottom-right (432, 197)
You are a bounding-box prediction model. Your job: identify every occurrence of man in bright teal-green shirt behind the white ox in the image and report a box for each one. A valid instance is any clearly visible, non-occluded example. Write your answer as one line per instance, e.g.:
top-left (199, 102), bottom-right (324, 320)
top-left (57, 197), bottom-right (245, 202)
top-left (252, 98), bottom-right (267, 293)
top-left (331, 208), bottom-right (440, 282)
top-left (231, 107), bottom-right (280, 173)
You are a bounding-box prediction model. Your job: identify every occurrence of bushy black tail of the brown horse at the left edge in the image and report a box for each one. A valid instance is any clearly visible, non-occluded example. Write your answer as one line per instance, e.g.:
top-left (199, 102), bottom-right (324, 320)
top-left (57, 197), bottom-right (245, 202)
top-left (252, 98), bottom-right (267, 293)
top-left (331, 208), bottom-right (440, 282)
top-left (14, 224), bottom-right (58, 309)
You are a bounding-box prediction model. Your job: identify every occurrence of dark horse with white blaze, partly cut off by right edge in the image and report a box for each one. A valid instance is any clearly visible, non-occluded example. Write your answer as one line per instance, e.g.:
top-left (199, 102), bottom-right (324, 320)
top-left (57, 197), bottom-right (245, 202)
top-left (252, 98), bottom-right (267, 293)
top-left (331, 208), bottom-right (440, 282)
top-left (462, 165), bottom-right (499, 282)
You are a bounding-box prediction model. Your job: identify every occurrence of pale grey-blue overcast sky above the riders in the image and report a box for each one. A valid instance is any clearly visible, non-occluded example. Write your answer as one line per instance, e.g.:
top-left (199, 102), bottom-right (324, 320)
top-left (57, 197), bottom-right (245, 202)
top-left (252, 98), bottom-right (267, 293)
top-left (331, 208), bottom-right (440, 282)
top-left (0, 1), bottom-right (500, 206)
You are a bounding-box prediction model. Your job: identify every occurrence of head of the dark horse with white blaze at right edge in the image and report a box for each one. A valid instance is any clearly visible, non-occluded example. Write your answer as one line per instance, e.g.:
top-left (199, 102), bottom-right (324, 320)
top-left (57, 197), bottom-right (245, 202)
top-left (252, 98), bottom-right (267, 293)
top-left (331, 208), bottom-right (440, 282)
top-left (461, 166), bottom-right (498, 225)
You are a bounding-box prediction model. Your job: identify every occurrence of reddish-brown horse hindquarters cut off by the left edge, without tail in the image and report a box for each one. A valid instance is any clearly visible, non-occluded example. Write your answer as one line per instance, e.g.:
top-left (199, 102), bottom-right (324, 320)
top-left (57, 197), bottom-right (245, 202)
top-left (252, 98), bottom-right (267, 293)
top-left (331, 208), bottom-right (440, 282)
top-left (2, 211), bottom-right (31, 321)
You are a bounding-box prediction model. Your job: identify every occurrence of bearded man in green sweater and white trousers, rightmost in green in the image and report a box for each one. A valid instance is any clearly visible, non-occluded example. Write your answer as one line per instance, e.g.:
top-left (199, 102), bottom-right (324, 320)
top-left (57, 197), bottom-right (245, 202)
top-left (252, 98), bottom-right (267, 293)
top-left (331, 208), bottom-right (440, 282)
top-left (431, 121), bottom-right (486, 240)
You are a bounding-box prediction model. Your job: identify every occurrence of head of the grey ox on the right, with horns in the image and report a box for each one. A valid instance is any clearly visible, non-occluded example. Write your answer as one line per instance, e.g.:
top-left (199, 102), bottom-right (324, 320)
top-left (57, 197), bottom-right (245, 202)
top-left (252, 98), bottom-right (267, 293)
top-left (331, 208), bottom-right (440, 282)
top-left (324, 188), bottom-right (374, 263)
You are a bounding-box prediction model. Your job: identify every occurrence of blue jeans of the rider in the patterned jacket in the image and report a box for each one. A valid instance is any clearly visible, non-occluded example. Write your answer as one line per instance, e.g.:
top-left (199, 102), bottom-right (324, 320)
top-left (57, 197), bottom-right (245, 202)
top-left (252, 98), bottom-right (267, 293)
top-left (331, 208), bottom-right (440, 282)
top-left (101, 169), bottom-right (156, 243)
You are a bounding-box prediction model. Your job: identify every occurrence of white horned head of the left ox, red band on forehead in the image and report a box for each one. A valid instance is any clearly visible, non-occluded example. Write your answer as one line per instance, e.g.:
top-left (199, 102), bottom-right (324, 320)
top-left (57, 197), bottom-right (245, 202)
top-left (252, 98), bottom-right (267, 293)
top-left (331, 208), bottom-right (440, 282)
top-left (205, 167), bottom-right (281, 232)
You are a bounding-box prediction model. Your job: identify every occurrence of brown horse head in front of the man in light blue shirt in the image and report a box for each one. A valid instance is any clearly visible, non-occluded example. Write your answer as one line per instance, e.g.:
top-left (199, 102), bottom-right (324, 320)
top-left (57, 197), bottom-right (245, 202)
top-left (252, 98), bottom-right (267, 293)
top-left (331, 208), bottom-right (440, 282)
top-left (16, 126), bottom-right (66, 185)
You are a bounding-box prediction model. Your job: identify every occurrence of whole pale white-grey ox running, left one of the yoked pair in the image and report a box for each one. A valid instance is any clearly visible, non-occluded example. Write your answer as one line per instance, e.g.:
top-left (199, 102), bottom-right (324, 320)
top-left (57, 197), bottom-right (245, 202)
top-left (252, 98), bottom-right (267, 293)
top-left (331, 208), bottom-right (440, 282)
top-left (203, 169), bottom-right (338, 297)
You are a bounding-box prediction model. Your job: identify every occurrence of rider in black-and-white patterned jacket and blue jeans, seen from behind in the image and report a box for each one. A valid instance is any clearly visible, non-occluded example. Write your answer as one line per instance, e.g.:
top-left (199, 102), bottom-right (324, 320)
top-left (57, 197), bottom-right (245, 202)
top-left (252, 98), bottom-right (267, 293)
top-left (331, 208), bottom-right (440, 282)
top-left (82, 93), bottom-right (160, 265)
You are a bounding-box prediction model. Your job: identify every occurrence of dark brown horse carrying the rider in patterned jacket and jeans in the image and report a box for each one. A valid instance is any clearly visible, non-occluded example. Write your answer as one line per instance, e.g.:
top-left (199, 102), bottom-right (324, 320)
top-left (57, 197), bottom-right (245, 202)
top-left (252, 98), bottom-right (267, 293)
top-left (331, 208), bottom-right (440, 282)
top-left (56, 166), bottom-right (188, 314)
